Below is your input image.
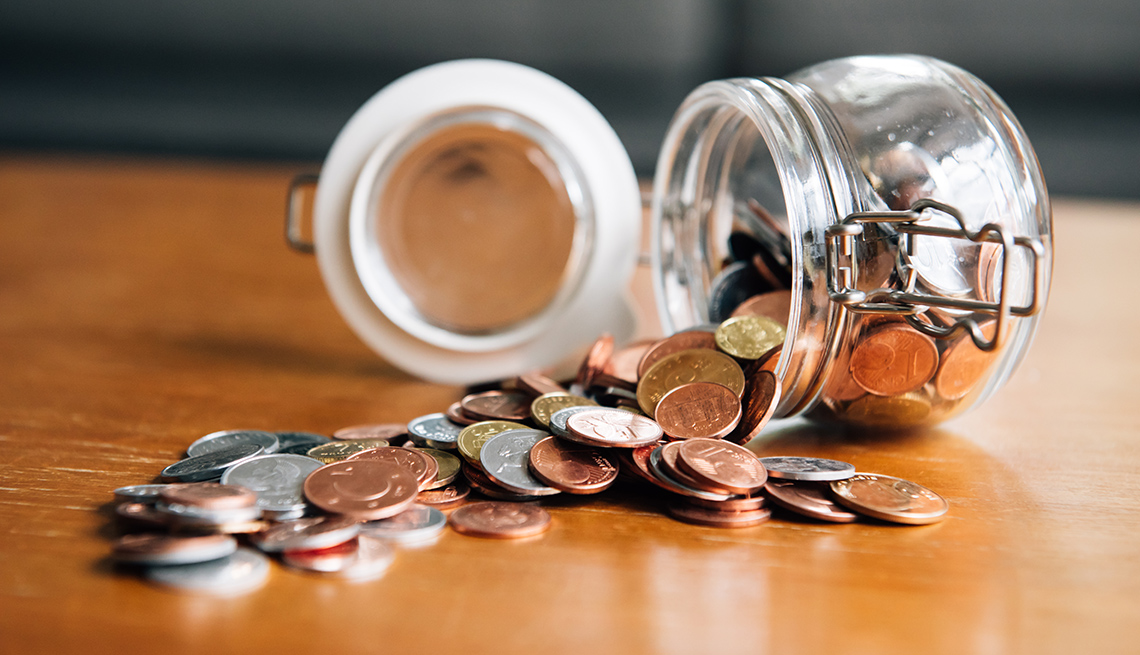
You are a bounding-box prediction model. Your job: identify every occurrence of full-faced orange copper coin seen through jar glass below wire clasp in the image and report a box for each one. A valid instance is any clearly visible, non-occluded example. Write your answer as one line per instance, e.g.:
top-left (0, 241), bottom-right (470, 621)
top-left (850, 324), bottom-right (938, 395)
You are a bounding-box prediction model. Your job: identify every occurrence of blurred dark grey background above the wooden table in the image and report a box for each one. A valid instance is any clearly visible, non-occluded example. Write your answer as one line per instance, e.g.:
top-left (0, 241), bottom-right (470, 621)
top-left (0, 0), bottom-right (1140, 197)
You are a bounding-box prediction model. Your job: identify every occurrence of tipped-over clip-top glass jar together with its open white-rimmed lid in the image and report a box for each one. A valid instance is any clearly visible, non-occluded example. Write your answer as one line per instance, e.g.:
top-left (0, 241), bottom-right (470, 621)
top-left (300, 56), bottom-right (1052, 427)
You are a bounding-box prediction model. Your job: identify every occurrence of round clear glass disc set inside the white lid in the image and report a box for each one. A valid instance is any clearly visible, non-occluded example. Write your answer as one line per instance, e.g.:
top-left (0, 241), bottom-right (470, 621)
top-left (352, 107), bottom-right (593, 349)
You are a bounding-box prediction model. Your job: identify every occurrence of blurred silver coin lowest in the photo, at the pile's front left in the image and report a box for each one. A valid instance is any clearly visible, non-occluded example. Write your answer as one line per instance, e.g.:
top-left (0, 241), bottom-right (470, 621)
top-left (144, 548), bottom-right (269, 596)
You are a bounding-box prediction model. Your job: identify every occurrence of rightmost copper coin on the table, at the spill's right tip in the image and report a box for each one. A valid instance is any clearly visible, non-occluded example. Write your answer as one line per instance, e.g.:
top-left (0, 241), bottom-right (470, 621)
top-left (831, 473), bottom-right (950, 525)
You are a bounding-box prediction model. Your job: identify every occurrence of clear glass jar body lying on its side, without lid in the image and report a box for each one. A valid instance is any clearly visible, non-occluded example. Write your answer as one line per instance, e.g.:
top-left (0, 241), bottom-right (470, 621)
top-left (653, 56), bottom-right (1052, 427)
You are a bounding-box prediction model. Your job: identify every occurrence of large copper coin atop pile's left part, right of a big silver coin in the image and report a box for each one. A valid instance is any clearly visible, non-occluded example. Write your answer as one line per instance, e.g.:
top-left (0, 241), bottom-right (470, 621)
top-left (304, 459), bottom-right (420, 521)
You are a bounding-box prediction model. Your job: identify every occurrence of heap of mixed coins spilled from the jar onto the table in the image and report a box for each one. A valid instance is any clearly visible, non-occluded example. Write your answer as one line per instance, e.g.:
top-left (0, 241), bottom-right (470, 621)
top-left (104, 323), bottom-right (948, 593)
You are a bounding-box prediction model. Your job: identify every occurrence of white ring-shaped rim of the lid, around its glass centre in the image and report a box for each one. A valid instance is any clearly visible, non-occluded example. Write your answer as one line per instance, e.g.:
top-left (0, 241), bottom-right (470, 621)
top-left (314, 59), bottom-right (641, 384)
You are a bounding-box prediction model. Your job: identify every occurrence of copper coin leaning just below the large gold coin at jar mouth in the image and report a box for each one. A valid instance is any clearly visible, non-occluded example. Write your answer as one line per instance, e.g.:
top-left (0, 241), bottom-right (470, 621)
top-left (653, 382), bottom-right (741, 439)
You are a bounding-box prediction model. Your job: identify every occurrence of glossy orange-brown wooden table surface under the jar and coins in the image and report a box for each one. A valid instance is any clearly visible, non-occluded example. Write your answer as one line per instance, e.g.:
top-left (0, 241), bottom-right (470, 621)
top-left (0, 155), bottom-right (1140, 655)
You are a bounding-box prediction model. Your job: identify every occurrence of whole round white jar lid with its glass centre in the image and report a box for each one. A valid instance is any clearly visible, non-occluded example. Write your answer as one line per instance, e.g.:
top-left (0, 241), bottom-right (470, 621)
top-left (314, 59), bottom-right (641, 384)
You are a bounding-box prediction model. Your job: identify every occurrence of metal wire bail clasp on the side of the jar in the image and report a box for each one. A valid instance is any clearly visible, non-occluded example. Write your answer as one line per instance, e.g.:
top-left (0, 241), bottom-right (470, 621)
top-left (827, 198), bottom-right (1045, 352)
